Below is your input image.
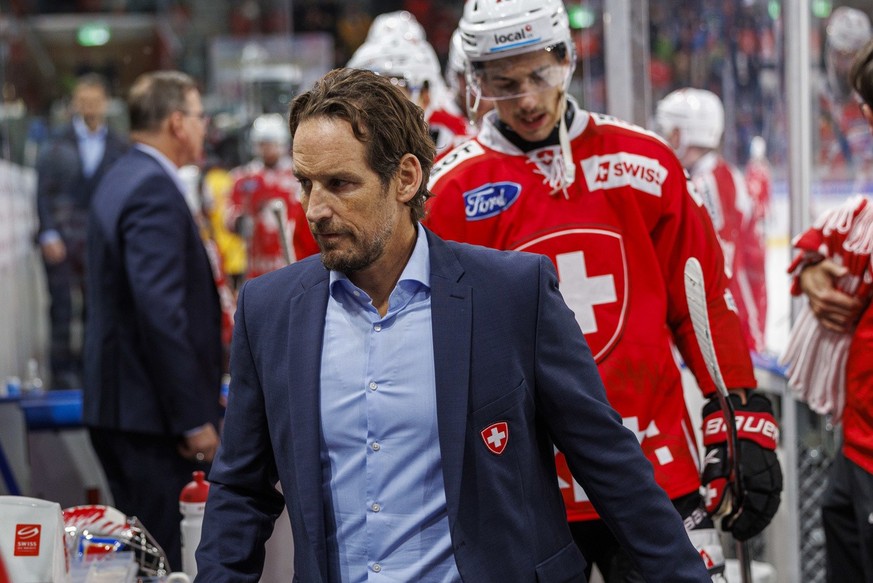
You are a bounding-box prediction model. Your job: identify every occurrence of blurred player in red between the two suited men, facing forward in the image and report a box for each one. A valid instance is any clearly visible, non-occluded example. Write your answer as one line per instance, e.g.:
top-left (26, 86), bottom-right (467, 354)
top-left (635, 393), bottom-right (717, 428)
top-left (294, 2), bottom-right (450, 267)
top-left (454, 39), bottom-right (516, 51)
top-left (226, 113), bottom-right (318, 278)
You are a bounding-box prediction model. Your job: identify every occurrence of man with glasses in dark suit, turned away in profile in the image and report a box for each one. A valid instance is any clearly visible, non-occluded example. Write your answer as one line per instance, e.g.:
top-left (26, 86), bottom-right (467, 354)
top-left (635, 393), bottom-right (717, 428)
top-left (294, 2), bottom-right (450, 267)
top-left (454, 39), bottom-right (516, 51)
top-left (83, 71), bottom-right (222, 568)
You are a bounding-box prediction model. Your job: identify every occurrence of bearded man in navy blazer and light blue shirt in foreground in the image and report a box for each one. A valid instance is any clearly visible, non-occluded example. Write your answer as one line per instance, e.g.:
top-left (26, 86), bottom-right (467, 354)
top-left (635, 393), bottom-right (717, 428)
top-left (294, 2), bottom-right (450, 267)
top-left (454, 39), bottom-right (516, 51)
top-left (197, 69), bottom-right (710, 583)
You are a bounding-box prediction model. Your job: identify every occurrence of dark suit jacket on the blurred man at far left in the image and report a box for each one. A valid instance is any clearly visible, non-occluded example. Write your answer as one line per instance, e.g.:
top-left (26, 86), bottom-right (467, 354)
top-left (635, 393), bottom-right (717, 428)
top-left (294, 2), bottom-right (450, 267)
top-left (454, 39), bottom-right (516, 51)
top-left (36, 124), bottom-right (127, 244)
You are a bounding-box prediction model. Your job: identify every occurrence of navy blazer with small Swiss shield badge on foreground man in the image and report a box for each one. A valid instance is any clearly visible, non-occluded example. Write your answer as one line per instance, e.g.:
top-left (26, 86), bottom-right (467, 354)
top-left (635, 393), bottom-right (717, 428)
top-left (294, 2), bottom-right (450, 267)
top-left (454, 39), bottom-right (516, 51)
top-left (197, 228), bottom-right (710, 583)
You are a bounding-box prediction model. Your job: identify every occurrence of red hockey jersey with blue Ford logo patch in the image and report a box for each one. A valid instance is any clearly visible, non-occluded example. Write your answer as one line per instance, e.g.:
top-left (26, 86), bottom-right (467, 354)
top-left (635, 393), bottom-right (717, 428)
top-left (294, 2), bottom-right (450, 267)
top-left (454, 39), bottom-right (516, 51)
top-left (426, 104), bottom-right (755, 520)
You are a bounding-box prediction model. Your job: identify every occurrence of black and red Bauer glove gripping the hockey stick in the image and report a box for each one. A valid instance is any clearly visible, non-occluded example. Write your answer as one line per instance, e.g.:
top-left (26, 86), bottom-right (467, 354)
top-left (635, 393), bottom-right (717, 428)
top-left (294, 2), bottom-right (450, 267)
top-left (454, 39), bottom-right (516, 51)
top-left (701, 392), bottom-right (782, 541)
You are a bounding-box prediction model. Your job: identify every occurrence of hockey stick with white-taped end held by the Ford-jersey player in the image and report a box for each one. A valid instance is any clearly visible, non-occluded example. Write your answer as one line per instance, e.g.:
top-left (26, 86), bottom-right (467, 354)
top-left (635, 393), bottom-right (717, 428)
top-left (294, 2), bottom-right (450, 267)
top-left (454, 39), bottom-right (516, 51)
top-left (685, 257), bottom-right (752, 583)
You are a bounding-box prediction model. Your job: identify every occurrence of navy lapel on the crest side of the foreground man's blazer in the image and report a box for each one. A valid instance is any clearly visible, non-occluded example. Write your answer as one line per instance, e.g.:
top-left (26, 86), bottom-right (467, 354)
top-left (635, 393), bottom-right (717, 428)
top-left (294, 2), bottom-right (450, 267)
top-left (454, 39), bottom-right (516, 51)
top-left (427, 231), bottom-right (473, 527)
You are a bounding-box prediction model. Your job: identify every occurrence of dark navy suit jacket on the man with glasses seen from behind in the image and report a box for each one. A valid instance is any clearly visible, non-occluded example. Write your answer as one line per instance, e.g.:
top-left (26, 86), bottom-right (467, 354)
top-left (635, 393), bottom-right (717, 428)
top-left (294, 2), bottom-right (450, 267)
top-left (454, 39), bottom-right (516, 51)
top-left (82, 148), bottom-right (222, 436)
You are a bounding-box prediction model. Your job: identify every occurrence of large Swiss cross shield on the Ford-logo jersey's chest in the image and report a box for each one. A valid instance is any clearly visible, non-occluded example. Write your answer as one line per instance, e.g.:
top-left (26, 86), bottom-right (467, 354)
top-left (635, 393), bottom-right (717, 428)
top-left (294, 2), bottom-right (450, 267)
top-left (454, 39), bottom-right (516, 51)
top-left (516, 227), bottom-right (628, 363)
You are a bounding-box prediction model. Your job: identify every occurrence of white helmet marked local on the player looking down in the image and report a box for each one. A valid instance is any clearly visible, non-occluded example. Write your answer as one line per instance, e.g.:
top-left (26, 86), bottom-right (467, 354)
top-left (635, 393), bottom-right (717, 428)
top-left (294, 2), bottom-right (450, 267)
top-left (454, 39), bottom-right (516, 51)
top-left (458, 0), bottom-right (575, 62)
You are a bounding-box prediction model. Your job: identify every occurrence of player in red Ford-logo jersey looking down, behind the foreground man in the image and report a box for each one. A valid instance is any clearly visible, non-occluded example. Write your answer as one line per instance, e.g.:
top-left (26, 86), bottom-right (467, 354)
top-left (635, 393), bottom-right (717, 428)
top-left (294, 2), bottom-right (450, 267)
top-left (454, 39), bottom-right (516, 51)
top-left (426, 0), bottom-right (782, 581)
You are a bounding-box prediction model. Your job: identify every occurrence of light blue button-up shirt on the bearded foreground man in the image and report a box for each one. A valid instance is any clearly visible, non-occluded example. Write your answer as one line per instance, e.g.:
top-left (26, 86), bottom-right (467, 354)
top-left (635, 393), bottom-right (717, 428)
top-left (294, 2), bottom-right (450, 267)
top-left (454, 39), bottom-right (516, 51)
top-left (321, 226), bottom-right (461, 583)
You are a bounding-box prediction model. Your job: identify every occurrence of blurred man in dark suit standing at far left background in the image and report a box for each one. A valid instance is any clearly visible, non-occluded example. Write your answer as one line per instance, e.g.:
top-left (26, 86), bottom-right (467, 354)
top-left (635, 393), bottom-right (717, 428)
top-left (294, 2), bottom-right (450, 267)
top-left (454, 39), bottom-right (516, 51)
top-left (36, 73), bottom-right (127, 389)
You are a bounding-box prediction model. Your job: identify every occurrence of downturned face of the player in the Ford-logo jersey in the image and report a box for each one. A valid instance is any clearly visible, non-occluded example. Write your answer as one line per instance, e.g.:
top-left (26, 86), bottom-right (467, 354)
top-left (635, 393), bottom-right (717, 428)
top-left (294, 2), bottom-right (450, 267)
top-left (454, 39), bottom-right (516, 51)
top-left (479, 50), bottom-right (569, 142)
